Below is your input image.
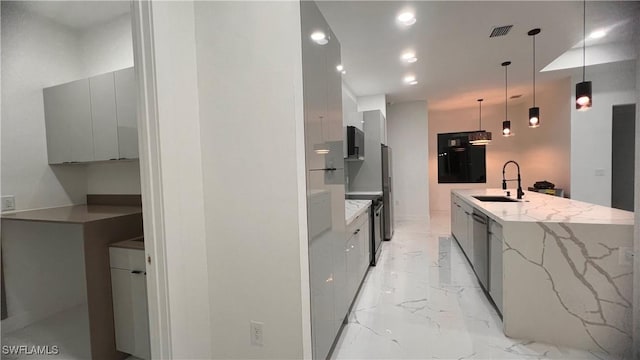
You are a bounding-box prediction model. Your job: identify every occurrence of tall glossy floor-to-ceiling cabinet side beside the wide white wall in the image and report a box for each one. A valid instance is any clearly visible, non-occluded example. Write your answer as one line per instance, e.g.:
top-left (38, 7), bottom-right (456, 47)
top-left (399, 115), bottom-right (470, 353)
top-left (300, 1), bottom-right (348, 359)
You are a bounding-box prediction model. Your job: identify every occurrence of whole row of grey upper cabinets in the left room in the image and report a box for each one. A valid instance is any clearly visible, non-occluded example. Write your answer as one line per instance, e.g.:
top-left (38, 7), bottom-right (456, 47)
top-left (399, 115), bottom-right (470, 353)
top-left (43, 68), bottom-right (138, 164)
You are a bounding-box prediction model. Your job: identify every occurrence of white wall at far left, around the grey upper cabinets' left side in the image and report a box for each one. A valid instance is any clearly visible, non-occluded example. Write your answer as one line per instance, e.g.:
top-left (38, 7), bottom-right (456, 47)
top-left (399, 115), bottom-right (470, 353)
top-left (1, 2), bottom-right (87, 210)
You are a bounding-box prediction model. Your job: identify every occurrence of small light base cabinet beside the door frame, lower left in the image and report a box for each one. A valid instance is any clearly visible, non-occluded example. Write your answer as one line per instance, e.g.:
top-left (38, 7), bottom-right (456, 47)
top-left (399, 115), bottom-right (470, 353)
top-left (109, 248), bottom-right (151, 359)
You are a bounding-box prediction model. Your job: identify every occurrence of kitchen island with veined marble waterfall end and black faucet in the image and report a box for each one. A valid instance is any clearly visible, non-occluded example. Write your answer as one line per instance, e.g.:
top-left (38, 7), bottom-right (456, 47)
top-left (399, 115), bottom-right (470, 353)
top-left (451, 189), bottom-right (634, 357)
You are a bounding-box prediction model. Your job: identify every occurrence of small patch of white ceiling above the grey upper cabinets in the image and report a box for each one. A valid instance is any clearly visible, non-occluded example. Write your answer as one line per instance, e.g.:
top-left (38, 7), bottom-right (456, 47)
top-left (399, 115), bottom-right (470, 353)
top-left (16, 0), bottom-right (131, 30)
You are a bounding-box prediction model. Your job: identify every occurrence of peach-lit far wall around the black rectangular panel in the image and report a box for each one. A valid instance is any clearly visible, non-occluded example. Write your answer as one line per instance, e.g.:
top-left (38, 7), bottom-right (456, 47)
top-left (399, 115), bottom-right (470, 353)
top-left (429, 78), bottom-right (571, 212)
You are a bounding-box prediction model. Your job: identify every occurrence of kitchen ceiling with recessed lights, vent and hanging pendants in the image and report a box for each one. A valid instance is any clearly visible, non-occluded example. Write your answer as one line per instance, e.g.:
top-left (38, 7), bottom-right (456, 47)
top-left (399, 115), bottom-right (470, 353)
top-left (318, 1), bottom-right (640, 109)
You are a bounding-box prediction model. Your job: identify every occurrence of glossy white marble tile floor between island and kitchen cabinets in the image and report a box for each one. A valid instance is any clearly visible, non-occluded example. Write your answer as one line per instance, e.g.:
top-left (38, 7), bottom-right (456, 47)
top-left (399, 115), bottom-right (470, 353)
top-left (332, 213), bottom-right (620, 360)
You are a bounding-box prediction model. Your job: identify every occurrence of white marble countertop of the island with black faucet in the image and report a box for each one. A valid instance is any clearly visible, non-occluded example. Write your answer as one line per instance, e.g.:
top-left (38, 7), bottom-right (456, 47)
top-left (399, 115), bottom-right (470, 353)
top-left (452, 189), bottom-right (634, 225)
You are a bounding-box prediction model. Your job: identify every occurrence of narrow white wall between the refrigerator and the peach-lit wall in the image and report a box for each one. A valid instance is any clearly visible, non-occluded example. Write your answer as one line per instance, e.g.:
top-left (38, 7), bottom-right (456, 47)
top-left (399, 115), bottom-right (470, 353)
top-left (387, 101), bottom-right (433, 221)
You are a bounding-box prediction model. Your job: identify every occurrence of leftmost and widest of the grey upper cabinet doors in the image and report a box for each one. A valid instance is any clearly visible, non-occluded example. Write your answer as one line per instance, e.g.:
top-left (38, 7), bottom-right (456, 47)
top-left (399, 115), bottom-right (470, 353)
top-left (43, 79), bottom-right (93, 164)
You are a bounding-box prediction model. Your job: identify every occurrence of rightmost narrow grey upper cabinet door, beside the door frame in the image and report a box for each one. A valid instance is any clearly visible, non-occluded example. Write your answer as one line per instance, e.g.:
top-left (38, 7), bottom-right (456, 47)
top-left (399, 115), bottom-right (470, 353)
top-left (114, 68), bottom-right (138, 159)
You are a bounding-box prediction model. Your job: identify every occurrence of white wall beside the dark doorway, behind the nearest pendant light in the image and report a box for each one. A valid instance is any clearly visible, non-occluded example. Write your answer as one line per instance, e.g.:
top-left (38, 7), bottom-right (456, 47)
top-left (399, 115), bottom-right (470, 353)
top-left (570, 61), bottom-right (637, 206)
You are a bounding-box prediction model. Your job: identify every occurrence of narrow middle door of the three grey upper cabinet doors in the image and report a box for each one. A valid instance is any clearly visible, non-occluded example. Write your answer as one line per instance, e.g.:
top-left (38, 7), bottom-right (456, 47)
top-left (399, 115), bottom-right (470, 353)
top-left (89, 73), bottom-right (119, 161)
